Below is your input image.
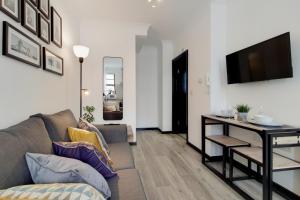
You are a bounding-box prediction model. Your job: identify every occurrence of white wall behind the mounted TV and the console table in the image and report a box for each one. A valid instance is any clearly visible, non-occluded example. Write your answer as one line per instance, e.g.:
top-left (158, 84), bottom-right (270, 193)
top-left (212, 0), bottom-right (300, 194)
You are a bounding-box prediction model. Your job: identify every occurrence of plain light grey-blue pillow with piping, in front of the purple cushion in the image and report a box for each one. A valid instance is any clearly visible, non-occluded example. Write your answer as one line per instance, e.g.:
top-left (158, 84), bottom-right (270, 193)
top-left (26, 153), bottom-right (111, 198)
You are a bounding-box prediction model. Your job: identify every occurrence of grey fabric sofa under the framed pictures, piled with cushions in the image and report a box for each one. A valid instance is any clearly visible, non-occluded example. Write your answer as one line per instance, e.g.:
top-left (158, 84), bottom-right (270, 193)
top-left (0, 110), bottom-right (146, 200)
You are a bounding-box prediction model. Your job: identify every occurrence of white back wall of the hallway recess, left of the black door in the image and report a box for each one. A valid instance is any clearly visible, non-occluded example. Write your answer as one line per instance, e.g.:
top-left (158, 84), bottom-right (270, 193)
top-left (136, 45), bottom-right (161, 128)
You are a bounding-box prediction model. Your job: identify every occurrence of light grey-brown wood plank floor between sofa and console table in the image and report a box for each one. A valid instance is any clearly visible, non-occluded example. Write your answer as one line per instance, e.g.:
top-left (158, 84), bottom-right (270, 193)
top-left (132, 131), bottom-right (281, 200)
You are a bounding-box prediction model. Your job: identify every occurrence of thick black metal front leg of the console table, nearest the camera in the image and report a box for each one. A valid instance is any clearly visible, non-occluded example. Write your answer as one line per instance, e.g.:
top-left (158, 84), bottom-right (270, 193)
top-left (262, 134), bottom-right (273, 200)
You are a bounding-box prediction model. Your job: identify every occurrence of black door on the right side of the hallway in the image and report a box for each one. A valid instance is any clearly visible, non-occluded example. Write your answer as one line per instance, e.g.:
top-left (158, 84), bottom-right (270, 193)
top-left (172, 50), bottom-right (188, 141)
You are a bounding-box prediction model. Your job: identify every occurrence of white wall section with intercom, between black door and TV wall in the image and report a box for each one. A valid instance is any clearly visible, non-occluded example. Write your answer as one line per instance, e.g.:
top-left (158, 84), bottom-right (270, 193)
top-left (174, 1), bottom-right (211, 148)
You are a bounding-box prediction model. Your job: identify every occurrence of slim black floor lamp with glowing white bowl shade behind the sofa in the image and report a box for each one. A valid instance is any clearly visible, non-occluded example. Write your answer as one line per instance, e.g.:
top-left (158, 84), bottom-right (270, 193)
top-left (73, 45), bottom-right (90, 117)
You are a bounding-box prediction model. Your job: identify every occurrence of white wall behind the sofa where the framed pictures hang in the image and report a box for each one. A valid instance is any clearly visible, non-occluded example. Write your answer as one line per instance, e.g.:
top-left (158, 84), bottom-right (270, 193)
top-left (0, 0), bottom-right (79, 128)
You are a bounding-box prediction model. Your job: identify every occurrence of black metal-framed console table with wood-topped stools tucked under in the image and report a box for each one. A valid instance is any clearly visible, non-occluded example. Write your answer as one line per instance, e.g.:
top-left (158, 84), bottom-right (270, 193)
top-left (202, 115), bottom-right (300, 200)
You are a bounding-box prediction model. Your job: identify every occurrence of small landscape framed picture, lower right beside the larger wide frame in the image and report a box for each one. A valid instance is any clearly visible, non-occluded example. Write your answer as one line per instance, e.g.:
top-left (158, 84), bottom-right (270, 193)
top-left (43, 47), bottom-right (64, 76)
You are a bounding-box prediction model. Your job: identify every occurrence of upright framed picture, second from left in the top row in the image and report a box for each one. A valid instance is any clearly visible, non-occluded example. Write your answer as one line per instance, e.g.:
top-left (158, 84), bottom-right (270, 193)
top-left (22, 0), bottom-right (38, 35)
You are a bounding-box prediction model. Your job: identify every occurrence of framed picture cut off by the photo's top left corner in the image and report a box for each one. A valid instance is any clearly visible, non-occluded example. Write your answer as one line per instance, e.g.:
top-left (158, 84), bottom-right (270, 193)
top-left (0, 0), bottom-right (21, 22)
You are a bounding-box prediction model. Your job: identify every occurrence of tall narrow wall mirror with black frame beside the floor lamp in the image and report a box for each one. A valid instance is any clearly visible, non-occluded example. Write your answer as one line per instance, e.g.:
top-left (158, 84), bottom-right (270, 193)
top-left (103, 57), bottom-right (123, 120)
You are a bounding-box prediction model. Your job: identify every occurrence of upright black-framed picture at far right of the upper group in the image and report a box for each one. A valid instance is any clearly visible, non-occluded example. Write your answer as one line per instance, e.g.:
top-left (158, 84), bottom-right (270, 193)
top-left (51, 7), bottom-right (62, 48)
